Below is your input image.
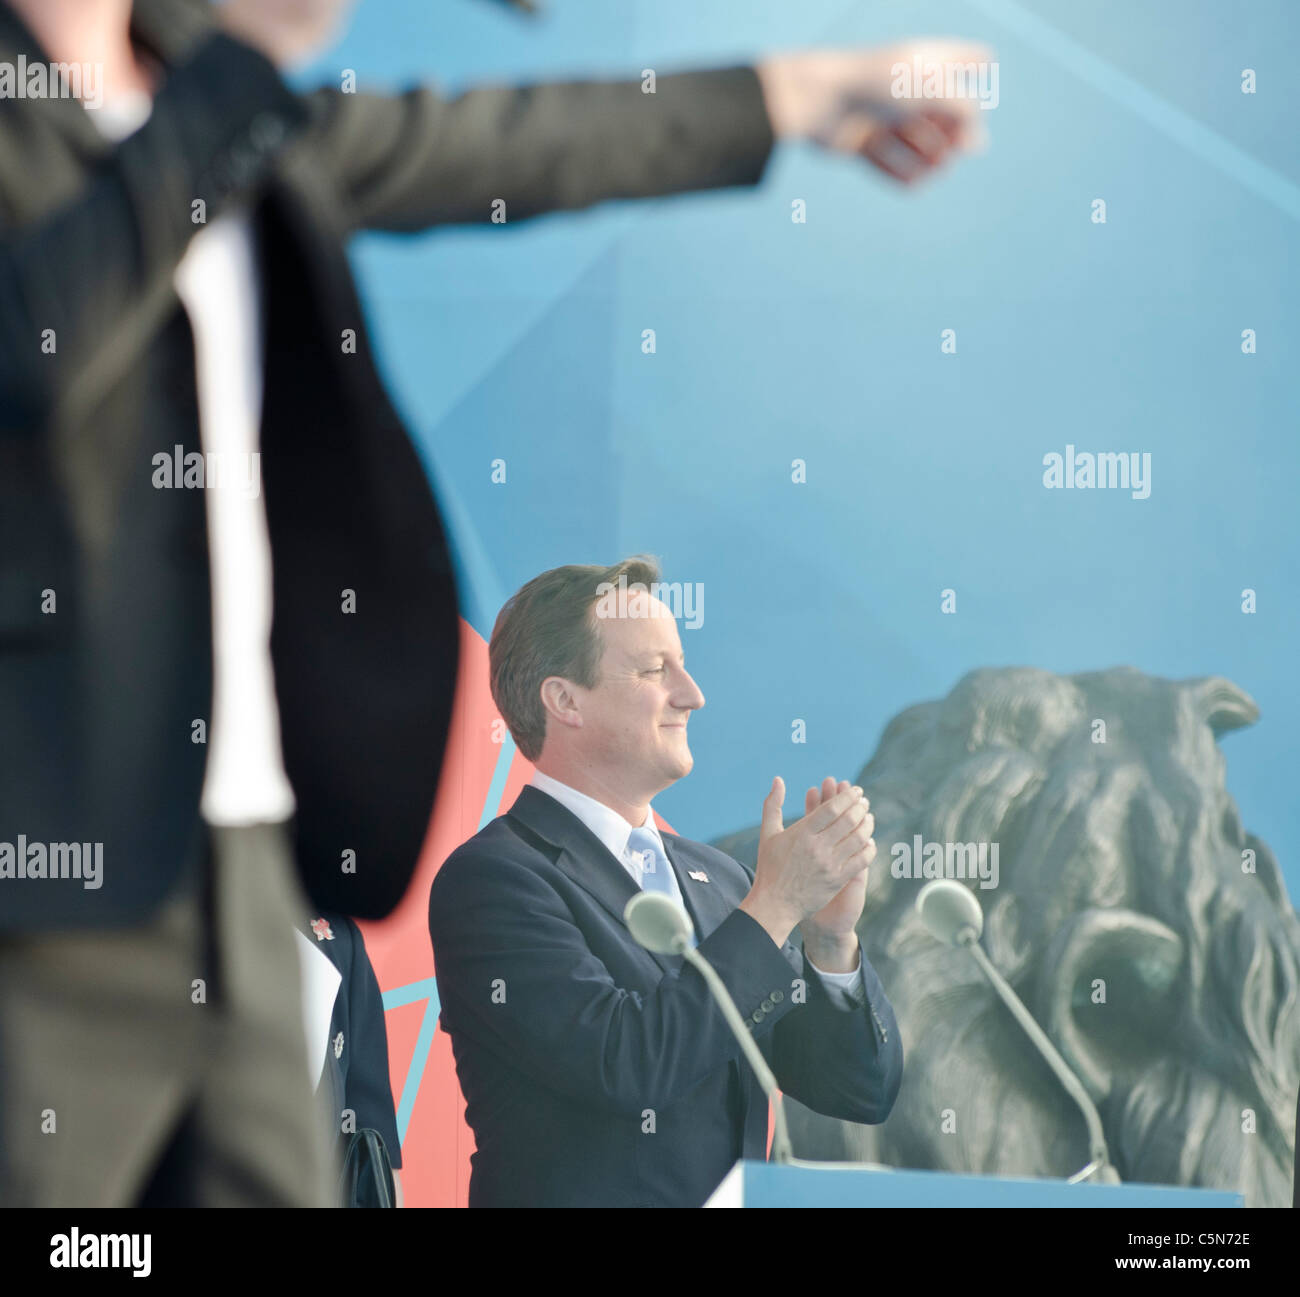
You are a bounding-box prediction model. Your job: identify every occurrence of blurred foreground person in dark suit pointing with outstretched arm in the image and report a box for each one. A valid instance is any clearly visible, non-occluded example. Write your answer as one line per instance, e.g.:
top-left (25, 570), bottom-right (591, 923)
top-left (0, 0), bottom-right (969, 1206)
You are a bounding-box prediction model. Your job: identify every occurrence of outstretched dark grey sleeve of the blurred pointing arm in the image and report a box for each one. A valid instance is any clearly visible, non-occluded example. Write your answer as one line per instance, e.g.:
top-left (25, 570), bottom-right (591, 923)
top-left (302, 68), bottom-right (772, 230)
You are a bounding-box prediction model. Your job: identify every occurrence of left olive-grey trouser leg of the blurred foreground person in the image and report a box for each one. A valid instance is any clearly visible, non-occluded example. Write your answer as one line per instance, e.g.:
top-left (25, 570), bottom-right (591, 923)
top-left (0, 862), bottom-right (215, 1207)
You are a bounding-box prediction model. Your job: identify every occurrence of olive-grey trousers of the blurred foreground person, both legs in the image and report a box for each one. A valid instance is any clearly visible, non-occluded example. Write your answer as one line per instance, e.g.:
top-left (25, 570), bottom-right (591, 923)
top-left (0, 825), bottom-right (335, 1207)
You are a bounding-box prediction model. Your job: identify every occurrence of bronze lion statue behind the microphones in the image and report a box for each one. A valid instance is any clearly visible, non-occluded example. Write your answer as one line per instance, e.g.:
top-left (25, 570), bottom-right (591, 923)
top-left (718, 668), bottom-right (1300, 1206)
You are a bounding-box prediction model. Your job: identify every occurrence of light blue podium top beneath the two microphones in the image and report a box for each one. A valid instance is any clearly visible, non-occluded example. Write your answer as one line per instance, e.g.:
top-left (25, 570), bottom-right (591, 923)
top-left (705, 1162), bottom-right (1244, 1207)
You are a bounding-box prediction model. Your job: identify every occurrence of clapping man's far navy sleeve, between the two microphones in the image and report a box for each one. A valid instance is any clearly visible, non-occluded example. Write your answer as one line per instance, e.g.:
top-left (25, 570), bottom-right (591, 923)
top-left (767, 951), bottom-right (902, 1124)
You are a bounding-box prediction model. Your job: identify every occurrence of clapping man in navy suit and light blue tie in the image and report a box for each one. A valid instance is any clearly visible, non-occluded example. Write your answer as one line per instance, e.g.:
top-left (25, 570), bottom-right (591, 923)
top-left (429, 559), bottom-right (902, 1206)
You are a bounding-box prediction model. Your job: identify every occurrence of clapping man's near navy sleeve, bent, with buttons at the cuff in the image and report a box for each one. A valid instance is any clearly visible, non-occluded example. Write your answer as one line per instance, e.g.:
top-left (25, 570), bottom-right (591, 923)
top-left (429, 853), bottom-right (794, 1114)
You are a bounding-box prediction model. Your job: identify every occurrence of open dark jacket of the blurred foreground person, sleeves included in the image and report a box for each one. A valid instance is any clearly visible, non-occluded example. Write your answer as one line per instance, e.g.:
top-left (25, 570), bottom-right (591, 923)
top-left (0, 0), bottom-right (772, 928)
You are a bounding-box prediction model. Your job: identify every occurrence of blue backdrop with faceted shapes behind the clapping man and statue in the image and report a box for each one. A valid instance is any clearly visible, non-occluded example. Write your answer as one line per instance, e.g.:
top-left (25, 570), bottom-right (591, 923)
top-left (303, 0), bottom-right (1300, 895)
